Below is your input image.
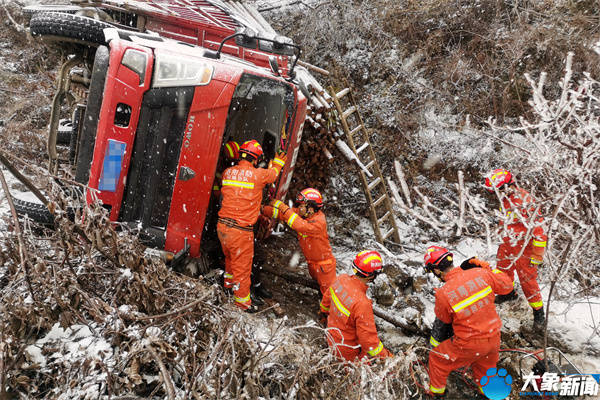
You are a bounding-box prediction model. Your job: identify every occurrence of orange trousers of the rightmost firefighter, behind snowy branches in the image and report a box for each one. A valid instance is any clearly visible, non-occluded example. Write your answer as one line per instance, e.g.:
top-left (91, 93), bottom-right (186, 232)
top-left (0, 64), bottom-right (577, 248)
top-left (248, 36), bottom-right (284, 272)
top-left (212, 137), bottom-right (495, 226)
top-left (496, 243), bottom-right (544, 310)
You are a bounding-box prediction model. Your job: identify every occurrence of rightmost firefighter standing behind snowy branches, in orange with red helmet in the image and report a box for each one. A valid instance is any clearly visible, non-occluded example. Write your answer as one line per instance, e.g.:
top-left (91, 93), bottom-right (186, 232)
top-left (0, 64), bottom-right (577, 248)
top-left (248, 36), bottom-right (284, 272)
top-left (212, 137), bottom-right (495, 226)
top-left (485, 169), bottom-right (547, 328)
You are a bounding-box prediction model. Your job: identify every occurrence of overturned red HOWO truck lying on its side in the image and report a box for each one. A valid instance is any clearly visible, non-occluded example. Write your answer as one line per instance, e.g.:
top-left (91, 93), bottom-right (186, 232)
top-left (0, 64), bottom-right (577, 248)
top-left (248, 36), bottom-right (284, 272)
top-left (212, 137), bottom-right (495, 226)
top-left (21, 0), bottom-right (309, 266)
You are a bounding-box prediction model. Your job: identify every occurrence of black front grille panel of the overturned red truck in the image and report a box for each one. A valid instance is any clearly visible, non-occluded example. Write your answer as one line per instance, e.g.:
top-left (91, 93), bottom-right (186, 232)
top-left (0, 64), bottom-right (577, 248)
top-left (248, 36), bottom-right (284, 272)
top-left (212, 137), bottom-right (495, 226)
top-left (119, 87), bottom-right (194, 238)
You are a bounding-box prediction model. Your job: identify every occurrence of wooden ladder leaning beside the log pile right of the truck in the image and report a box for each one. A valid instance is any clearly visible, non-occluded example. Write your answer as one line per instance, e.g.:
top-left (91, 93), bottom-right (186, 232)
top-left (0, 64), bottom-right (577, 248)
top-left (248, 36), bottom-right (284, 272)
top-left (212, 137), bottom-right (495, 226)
top-left (329, 87), bottom-right (400, 244)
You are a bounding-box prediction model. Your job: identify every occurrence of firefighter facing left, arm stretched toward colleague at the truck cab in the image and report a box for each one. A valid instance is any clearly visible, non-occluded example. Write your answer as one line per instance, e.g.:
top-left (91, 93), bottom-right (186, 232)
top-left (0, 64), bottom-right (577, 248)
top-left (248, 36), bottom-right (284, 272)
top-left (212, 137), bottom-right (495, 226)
top-left (262, 188), bottom-right (336, 311)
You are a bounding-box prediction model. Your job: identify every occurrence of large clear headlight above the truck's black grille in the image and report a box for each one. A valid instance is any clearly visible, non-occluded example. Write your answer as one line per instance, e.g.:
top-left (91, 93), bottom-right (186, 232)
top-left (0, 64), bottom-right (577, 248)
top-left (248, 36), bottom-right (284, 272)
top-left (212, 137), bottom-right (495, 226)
top-left (152, 49), bottom-right (214, 87)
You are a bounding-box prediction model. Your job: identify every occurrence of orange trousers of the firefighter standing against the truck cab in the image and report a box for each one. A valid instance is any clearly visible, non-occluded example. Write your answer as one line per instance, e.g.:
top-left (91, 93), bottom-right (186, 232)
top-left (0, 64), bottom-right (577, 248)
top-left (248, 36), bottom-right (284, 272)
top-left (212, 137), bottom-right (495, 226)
top-left (217, 222), bottom-right (254, 309)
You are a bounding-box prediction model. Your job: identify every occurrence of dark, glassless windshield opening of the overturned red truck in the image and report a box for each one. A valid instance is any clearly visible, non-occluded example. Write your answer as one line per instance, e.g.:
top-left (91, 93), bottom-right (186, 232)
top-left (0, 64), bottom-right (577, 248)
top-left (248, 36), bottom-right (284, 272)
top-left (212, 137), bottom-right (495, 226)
top-left (223, 73), bottom-right (294, 160)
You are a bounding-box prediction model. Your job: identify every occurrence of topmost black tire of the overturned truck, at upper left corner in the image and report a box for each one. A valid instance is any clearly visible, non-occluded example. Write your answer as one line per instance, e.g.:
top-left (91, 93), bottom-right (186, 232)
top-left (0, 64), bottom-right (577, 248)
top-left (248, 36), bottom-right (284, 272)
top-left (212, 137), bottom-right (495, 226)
top-left (29, 12), bottom-right (113, 46)
